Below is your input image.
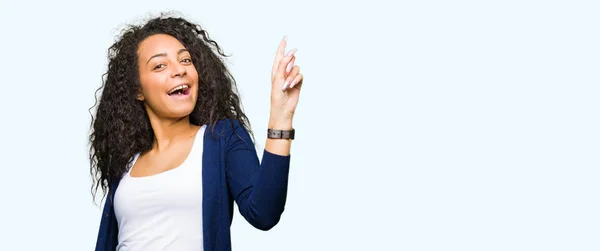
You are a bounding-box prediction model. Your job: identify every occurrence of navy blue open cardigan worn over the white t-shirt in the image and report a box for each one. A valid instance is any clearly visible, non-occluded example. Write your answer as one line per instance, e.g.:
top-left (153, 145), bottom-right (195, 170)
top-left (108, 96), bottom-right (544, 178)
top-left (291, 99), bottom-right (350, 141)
top-left (96, 119), bottom-right (290, 251)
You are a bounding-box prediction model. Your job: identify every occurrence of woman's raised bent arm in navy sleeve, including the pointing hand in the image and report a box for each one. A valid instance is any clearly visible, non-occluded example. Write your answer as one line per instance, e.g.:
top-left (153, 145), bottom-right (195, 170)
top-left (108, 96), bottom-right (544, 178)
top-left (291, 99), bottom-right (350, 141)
top-left (227, 38), bottom-right (303, 230)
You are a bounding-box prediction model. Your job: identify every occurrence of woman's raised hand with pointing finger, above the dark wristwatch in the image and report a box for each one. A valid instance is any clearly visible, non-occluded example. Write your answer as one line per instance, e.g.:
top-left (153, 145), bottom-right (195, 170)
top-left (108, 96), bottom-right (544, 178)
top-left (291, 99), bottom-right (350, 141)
top-left (269, 38), bottom-right (303, 129)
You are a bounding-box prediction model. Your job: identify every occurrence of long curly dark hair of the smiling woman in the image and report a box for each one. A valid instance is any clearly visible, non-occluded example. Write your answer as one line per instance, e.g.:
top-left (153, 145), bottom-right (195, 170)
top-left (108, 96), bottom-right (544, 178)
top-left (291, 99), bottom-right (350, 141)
top-left (89, 13), bottom-right (252, 202)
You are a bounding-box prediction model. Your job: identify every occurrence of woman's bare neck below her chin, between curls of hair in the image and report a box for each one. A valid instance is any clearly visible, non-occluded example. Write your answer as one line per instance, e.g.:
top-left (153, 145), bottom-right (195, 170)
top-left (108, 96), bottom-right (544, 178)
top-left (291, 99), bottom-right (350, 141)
top-left (149, 113), bottom-right (197, 152)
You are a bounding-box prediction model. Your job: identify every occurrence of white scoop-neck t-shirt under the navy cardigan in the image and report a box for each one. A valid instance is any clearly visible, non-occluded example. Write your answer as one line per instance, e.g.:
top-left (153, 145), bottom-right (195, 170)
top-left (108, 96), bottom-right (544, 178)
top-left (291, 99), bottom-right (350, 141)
top-left (114, 126), bottom-right (205, 251)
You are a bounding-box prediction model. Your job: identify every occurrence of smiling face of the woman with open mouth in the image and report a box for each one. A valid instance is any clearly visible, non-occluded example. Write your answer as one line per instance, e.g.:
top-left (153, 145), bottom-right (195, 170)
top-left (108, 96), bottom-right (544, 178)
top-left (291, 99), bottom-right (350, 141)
top-left (137, 34), bottom-right (198, 119)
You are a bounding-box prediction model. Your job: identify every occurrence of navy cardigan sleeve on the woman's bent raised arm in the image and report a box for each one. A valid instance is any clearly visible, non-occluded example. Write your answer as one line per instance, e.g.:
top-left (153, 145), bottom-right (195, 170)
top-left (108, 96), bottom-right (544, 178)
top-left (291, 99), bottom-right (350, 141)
top-left (225, 120), bottom-right (290, 231)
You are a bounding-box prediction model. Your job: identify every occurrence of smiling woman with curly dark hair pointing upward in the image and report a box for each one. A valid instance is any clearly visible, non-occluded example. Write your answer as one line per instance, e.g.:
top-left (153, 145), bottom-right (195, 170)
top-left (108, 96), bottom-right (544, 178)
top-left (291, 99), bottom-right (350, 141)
top-left (90, 16), bottom-right (303, 251)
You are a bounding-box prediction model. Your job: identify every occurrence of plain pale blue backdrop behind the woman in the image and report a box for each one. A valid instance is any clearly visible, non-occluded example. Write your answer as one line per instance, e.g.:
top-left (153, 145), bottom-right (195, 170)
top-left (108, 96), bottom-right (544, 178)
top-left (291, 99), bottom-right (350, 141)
top-left (0, 0), bottom-right (600, 251)
